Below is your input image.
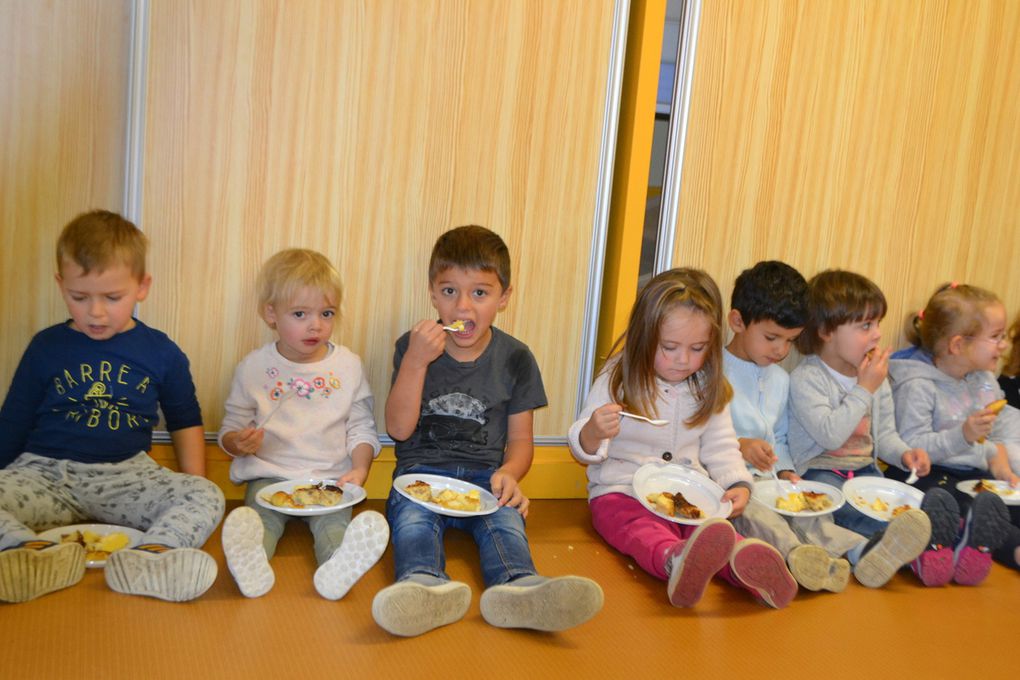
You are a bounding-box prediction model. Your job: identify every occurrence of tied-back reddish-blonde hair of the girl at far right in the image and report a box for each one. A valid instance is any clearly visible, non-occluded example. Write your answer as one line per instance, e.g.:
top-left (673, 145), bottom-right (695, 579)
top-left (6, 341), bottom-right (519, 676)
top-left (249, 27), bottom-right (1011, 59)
top-left (904, 283), bottom-right (1002, 357)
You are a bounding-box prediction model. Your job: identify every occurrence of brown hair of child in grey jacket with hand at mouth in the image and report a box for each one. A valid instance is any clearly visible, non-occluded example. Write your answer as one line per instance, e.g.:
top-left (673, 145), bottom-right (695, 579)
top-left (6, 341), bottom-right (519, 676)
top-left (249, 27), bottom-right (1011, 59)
top-left (797, 269), bottom-right (888, 354)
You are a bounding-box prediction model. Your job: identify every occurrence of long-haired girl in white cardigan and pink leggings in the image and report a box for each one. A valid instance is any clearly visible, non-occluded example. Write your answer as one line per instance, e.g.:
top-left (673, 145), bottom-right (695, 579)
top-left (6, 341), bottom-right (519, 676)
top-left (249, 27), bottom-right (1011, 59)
top-left (568, 269), bottom-right (797, 609)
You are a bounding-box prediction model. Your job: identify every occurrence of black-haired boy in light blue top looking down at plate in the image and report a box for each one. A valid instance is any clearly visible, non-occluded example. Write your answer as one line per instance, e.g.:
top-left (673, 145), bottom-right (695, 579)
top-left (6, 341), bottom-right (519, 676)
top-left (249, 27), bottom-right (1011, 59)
top-left (723, 261), bottom-right (923, 592)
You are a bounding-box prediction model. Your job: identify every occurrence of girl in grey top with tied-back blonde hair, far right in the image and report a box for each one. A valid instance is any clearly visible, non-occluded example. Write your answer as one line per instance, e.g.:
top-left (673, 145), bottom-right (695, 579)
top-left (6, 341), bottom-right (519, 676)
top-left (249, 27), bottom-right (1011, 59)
top-left (886, 283), bottom-right (1020, 585)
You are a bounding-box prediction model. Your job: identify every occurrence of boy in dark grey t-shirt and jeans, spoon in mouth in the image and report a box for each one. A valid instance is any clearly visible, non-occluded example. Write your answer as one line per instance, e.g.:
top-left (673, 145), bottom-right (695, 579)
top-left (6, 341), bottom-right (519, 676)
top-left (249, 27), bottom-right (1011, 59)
top-left (372, 226), bottom-right (603, 636)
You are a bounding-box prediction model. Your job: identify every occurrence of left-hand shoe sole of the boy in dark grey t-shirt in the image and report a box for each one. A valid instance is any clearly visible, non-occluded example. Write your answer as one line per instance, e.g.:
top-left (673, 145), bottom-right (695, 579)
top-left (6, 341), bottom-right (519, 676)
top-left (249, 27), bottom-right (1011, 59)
top-left (372, 581), bottom-right (471, 637)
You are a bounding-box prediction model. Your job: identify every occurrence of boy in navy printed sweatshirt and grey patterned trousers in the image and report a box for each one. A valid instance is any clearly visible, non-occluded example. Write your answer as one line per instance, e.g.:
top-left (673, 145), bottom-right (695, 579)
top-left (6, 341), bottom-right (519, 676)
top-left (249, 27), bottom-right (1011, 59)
top-left (0, 210), bottom-right (223, 603)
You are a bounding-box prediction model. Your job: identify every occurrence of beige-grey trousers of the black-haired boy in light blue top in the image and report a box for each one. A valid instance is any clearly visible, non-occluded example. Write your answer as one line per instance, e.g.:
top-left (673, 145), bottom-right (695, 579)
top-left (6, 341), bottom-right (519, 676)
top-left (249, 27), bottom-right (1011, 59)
top-left (732, 501), bottom-right (866, 558)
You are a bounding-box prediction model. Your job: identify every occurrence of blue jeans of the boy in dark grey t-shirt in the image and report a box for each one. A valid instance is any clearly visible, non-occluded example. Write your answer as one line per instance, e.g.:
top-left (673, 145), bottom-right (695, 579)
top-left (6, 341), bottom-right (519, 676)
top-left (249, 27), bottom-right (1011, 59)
top-left (386, 465), bottom-right (536, 587)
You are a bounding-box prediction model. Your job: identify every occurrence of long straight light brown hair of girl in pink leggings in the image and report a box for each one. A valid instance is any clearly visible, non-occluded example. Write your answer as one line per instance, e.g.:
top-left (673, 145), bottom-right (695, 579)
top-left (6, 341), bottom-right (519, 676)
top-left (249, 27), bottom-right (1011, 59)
top-left (609, 268), bottom-right (733, 427)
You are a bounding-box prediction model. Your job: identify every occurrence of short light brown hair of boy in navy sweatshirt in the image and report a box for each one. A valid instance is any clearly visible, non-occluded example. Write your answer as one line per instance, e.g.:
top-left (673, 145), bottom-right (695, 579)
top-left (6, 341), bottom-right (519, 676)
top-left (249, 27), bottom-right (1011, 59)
top-left (57, 210), bottom-right (149, 281)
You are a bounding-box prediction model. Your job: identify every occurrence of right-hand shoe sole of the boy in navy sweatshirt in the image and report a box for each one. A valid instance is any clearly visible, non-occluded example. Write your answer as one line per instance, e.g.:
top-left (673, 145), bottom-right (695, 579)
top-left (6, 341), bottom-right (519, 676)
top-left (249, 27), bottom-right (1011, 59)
top-left (105, 547), bottom-right (216, 603)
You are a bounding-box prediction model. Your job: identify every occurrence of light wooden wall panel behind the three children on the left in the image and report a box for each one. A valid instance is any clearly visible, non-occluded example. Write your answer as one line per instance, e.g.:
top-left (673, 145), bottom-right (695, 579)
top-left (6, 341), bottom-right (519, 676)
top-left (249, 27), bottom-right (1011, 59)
top-left (143, 0), bottom-right (613, 436)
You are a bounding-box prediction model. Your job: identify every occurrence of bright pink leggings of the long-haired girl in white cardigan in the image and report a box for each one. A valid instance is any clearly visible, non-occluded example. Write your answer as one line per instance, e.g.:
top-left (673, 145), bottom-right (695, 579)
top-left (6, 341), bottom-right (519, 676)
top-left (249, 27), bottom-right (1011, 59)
top-left (589, 493), bottom-right (746, 588)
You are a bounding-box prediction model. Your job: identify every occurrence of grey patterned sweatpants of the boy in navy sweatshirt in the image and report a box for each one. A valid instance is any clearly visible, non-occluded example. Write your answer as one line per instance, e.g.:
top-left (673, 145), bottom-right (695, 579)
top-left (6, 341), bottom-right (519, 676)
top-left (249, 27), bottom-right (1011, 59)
top-left (0, 452), bottom-right (223, 550)
